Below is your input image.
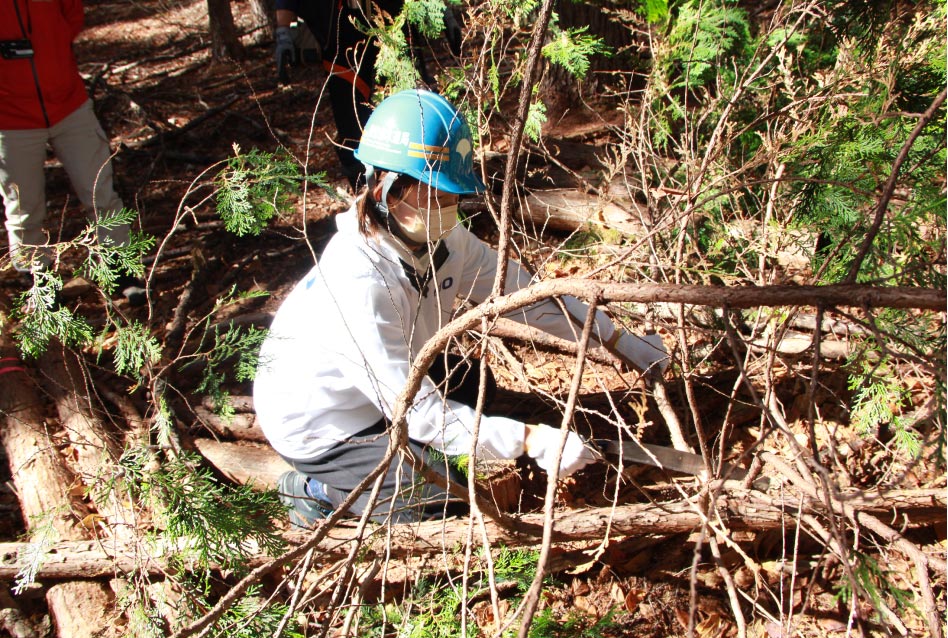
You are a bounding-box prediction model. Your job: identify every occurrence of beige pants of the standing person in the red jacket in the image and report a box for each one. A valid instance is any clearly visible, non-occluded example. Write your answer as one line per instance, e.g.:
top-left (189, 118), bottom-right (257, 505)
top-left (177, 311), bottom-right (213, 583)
top-left (0, 100), bottom-right (129, 271)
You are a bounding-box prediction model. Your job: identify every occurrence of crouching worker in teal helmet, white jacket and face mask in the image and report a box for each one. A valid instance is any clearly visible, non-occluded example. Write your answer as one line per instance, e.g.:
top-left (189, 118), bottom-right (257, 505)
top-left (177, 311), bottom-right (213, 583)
top-left (254, 90), bottom-right (667, 524)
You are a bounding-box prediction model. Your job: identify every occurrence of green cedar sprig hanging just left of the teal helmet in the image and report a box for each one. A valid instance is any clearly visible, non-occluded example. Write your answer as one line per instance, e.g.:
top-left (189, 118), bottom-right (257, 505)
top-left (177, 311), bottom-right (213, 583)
top-left (216, 144), bottom-right (318, 237)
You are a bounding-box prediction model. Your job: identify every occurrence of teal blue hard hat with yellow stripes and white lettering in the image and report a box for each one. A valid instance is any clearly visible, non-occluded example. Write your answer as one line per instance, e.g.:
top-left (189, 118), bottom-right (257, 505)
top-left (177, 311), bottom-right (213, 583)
top-left (355, 89), bottom-right (485, 195)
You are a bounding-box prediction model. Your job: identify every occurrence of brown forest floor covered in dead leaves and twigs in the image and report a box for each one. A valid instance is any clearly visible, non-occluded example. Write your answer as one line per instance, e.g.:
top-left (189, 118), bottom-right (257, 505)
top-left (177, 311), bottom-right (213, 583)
top-left (0, 0), bottom-right (944, 638)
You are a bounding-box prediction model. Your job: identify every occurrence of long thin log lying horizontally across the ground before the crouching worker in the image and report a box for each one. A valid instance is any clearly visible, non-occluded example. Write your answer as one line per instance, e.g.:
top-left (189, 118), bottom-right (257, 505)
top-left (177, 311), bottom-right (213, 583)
top-left (0, 489), bottom-right (948, 580)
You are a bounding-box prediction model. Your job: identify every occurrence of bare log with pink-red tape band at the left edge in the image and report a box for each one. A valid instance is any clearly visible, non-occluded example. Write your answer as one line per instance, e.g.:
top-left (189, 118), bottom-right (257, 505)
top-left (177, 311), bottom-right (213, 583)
top-left (0, 334), bottom-right (115, 638)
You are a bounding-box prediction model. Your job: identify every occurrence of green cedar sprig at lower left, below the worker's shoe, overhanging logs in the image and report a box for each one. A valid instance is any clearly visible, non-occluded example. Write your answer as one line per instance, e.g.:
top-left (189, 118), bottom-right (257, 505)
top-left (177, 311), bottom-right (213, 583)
top-left (119, 449), bottom-right (286, 574)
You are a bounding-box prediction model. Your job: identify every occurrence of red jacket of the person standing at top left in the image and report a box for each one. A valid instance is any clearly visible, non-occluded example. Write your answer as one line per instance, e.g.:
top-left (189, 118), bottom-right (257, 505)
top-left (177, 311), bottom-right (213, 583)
top-left (0, 0), bottom-right (88, 130)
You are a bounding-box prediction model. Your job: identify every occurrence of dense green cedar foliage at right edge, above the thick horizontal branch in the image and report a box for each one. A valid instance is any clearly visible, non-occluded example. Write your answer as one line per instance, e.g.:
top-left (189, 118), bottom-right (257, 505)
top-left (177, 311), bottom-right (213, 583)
top-left (787, 3), bottom-right (948, 287)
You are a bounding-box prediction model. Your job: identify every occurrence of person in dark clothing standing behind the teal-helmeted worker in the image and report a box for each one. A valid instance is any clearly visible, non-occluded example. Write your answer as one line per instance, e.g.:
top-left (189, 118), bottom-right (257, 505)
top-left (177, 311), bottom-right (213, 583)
top-left (275, 0), bottom-right (461, 190)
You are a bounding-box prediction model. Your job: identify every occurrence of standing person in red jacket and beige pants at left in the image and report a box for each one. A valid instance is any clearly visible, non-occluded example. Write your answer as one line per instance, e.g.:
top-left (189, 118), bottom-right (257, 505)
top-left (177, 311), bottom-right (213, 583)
top-left (0, 0), bottom-right (145, 305)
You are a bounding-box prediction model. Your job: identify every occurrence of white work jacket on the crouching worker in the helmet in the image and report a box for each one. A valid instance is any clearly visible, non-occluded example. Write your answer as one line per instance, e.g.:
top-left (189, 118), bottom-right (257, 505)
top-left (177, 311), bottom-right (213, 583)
top-left (254, 207), bottom-right (613, 460)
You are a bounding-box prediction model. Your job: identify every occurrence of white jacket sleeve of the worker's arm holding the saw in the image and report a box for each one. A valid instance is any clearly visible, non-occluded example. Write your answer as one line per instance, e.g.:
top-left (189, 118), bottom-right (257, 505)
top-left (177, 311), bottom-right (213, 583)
top-left (334, 273), bottom-right (524, 459)
